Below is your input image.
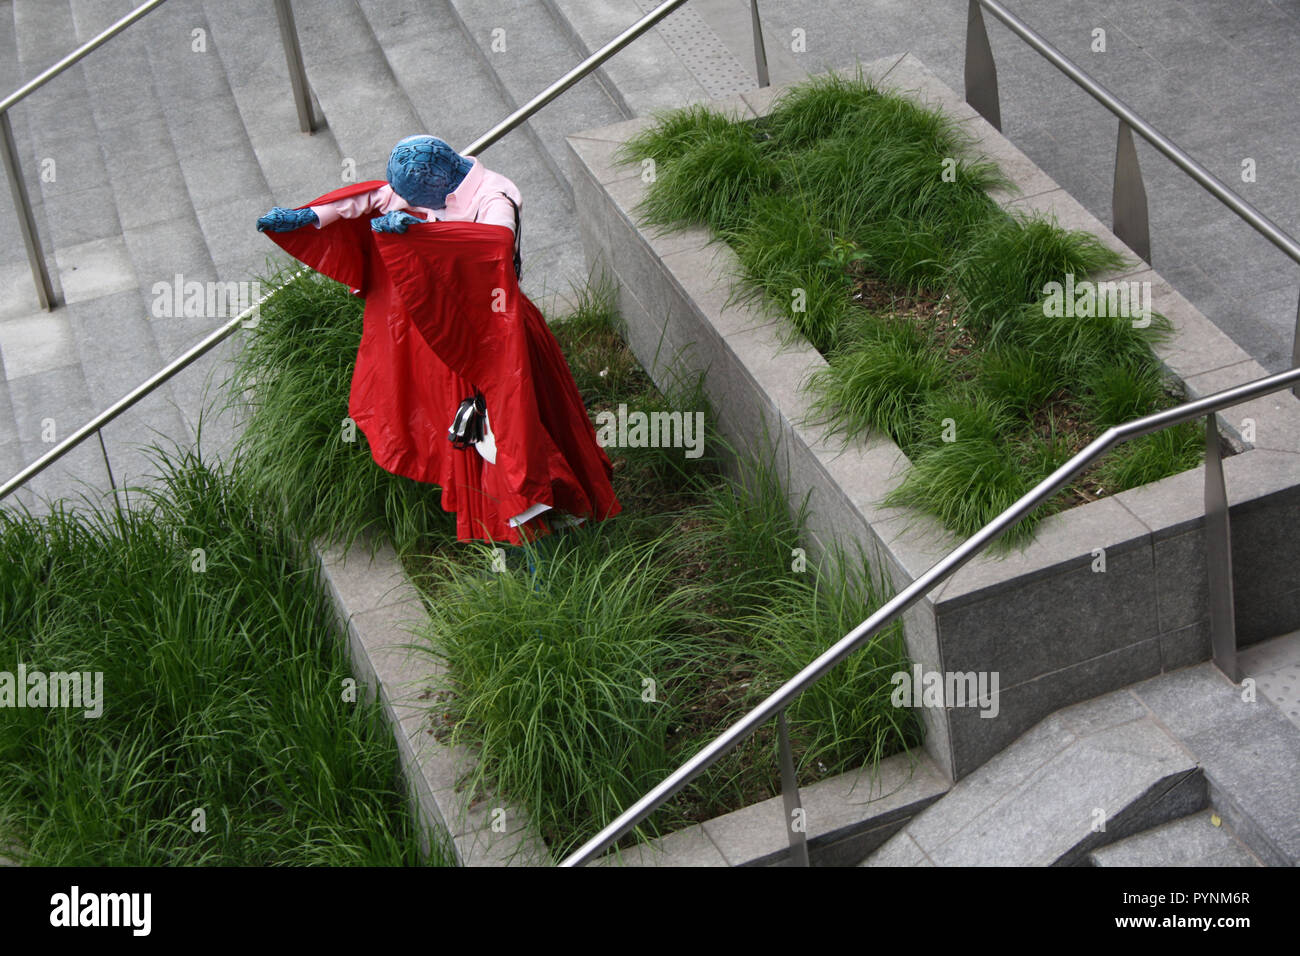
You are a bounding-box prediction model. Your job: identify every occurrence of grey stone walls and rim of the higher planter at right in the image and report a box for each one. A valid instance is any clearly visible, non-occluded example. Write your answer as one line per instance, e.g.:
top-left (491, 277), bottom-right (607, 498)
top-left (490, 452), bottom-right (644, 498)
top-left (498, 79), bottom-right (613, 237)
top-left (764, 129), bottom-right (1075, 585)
top-left (568, 55), bottom-right (1300, 779)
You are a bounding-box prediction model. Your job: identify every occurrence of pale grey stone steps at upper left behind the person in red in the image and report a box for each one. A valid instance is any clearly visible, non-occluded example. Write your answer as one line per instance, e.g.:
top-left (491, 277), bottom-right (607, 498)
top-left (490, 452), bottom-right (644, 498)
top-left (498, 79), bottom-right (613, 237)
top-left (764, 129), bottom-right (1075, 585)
top-left (0, 0), bottom-right (753, 511)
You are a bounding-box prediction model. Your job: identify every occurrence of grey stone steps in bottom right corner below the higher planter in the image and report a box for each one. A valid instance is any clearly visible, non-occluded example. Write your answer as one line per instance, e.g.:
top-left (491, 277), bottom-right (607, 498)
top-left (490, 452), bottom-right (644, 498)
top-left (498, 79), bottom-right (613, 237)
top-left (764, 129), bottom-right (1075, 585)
top-left (861, 633), bottom-right (1300, 866)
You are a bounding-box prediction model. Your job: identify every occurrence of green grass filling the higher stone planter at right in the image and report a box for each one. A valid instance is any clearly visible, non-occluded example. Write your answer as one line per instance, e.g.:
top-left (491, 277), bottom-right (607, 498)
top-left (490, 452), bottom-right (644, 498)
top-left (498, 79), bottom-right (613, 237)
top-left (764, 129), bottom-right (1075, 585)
top-left (624, 72), bottom-right (1197, 541)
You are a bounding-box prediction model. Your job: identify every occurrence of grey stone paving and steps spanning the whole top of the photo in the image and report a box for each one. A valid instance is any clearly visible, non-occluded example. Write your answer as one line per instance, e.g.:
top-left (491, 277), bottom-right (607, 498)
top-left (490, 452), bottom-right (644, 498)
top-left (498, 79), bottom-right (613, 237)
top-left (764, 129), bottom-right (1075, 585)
top-left (0, 0), bottom-right (1300, 512)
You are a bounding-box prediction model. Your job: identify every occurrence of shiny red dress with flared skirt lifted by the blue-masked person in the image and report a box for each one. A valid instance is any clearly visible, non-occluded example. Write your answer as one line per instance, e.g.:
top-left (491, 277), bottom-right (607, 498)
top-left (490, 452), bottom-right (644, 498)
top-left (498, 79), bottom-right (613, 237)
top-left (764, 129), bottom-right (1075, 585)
top-left (267, 182), bottom-right (620, 544)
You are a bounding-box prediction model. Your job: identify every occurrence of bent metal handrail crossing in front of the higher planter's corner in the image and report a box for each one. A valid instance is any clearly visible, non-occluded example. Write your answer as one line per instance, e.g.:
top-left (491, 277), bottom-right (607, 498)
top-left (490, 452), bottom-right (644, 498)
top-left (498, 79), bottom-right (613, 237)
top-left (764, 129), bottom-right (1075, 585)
top-left (559, 368), bottom-right (1300, 866)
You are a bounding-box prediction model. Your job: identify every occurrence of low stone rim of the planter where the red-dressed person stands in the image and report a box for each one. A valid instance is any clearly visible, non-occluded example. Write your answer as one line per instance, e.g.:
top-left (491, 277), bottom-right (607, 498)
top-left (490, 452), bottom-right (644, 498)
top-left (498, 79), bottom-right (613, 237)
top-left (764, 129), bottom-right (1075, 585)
top-left (309, 541), bottom-right (949, 866)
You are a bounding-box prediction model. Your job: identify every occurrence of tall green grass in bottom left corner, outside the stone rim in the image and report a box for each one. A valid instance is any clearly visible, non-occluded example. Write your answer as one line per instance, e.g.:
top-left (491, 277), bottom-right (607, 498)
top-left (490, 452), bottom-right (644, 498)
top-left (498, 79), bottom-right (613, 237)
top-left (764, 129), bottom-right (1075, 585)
top-left (0, 449), bottom-right (454, 866)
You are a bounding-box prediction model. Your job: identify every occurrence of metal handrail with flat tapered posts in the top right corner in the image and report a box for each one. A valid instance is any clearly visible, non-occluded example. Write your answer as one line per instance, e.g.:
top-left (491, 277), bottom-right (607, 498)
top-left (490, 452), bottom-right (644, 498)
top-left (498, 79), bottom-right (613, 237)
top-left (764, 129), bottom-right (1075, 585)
top-left (966, 0), bottom-right (1300, 382)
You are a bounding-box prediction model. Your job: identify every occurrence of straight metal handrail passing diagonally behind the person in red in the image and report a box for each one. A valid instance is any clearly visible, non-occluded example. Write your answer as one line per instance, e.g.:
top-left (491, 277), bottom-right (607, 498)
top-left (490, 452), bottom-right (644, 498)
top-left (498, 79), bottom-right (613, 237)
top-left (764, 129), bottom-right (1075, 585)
top-left (0, 0), bottom-right (767, 499)
